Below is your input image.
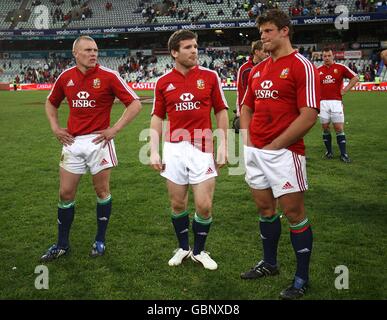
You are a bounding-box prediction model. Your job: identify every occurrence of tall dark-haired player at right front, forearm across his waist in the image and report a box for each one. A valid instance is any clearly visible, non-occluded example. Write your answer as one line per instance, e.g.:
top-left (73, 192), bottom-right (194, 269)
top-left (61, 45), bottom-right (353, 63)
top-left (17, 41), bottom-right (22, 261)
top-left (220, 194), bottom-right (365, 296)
top-left (241, 10), bottom-right (320, 299)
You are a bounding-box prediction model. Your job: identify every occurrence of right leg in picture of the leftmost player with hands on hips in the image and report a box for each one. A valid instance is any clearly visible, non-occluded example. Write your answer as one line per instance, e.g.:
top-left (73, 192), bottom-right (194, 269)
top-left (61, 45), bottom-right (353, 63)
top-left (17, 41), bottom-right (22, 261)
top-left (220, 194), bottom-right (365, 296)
top-left (90, 168), bottom-right (112, 256)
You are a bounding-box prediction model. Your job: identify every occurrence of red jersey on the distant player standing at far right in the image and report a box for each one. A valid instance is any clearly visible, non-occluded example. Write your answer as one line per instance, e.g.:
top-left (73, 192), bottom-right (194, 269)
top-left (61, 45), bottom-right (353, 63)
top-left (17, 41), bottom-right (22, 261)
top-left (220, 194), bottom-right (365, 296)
top-left (318, 62), bottom-right (357, 100)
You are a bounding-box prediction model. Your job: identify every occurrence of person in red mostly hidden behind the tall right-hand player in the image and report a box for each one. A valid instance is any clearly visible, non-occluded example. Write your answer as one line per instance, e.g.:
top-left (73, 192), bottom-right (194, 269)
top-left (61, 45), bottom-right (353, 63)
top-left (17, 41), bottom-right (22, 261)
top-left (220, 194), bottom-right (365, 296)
top-left (232, 40), bottom-right (268, 133)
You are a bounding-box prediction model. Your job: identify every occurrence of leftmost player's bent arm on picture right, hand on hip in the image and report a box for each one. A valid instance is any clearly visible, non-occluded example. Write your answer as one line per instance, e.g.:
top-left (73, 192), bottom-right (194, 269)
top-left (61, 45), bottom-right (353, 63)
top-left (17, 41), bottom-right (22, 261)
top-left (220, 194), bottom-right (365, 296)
top-left (93, 99), bottom-right (141, 146)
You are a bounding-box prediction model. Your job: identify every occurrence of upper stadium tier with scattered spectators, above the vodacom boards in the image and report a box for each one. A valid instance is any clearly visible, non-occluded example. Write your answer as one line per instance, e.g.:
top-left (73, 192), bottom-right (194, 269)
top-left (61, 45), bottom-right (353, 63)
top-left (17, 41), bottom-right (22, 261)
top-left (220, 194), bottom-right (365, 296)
top-left (0, 0), bottom-right (387, 29)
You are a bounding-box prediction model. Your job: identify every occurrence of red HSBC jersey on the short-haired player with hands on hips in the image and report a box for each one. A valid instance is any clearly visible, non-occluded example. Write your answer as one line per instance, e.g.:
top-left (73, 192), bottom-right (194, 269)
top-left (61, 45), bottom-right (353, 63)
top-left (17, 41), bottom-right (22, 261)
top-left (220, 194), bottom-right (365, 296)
top-left (48, 64), bottom-right (139, 136)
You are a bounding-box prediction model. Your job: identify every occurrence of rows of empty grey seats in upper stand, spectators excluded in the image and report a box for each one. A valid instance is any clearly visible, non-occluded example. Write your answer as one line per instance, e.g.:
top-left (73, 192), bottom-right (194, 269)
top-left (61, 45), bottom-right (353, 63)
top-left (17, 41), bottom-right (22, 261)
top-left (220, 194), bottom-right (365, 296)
top-left (0, 0), bottom-right (376, 29)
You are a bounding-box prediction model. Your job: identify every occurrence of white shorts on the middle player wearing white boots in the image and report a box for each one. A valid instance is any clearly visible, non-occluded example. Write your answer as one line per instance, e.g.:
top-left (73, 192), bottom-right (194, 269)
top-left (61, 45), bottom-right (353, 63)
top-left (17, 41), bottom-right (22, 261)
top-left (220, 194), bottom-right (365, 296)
top-left (160, 141), bottom-right (218, 185)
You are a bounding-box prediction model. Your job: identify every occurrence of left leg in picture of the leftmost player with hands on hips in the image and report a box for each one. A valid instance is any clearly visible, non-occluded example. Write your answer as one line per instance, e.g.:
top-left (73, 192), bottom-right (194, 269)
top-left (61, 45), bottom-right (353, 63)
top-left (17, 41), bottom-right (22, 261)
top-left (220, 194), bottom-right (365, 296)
top-left (40, 167), bottom-right (82, 262)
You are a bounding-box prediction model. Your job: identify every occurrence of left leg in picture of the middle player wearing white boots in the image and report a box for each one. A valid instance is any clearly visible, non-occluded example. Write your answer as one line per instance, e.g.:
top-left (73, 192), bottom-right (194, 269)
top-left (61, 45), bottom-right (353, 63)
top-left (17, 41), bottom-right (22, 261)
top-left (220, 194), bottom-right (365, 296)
top-left (167, 179), bottom-right (191, 266)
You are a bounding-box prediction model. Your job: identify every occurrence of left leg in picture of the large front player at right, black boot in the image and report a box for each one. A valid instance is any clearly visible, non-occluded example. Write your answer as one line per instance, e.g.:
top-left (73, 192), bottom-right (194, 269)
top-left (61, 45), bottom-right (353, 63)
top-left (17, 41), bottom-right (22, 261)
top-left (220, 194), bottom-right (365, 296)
top-left (241, 188), bottom-right (281, 279)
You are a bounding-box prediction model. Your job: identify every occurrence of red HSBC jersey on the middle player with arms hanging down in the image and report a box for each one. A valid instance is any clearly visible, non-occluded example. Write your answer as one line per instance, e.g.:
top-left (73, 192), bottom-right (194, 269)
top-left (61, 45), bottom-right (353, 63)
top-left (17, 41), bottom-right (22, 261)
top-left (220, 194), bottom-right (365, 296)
top-left (151, 66), bottom-right (228, 152)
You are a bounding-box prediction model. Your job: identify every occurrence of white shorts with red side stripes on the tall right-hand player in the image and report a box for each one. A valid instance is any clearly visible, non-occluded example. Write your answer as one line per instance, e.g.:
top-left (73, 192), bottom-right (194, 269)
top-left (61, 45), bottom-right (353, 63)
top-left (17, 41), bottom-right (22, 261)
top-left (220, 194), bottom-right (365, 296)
top-left (244, 146), bottom-right (308, 198)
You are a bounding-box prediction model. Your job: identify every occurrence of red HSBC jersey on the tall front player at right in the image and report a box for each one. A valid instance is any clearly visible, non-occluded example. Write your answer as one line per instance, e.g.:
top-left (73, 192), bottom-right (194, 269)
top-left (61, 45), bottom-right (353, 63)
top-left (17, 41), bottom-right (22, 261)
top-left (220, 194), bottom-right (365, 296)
top-left (242, 52), bottom-right (320, 155)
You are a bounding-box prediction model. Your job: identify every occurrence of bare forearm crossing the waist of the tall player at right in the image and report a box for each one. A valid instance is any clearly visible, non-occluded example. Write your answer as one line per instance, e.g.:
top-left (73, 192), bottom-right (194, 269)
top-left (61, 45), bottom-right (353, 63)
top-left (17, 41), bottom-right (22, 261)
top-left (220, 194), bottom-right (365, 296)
top-left (263, 107), bottom-right (318, 150)
